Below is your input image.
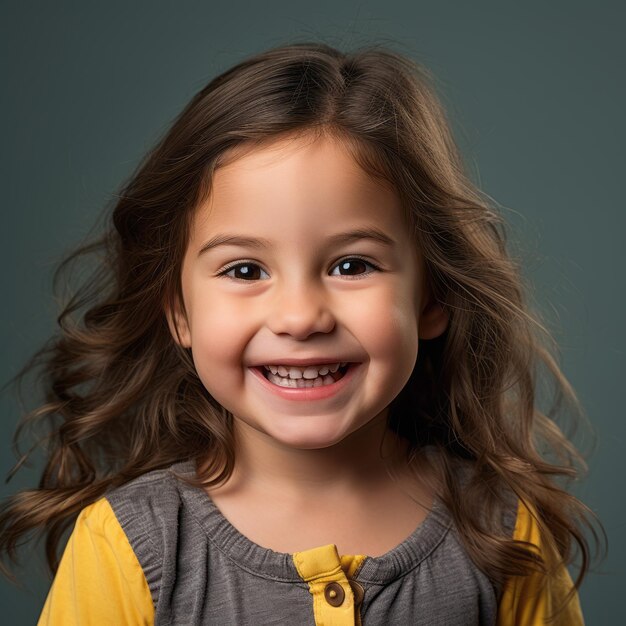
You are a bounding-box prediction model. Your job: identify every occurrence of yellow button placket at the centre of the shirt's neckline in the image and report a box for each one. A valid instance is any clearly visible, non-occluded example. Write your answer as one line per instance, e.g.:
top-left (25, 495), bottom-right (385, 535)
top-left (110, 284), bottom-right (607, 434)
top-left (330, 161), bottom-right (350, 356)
top-left (293, 544), bottom-right (365, 626)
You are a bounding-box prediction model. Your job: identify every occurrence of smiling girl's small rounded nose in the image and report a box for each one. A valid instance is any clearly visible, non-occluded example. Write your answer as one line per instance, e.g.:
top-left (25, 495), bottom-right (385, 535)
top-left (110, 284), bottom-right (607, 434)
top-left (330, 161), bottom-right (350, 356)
top-left (267, 281), bottom-right (336, 340)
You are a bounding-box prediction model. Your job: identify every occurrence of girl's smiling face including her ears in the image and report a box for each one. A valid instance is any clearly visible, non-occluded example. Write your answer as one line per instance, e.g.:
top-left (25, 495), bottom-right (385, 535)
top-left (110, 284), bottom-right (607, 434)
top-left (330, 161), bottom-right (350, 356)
top-left (173, 136), bottom-right (447, 449)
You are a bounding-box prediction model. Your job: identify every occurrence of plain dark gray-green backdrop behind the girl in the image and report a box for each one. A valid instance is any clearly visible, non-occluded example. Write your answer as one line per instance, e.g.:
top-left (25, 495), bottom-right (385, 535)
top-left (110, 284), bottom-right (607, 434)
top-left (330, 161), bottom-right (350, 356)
top-left (0, 0), bottom-right (626, 624)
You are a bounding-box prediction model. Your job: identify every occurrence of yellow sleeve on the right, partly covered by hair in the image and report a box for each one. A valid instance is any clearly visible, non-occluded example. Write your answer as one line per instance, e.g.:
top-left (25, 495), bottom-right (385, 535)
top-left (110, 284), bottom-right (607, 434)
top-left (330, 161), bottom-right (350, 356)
top-left (497, 502), bottom-right (584, 626)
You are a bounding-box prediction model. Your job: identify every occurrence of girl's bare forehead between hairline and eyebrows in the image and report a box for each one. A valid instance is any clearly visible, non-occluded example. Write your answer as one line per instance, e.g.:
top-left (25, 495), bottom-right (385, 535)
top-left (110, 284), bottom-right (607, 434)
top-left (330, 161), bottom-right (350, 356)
top-left (195, 133), bottom-right (408, 244)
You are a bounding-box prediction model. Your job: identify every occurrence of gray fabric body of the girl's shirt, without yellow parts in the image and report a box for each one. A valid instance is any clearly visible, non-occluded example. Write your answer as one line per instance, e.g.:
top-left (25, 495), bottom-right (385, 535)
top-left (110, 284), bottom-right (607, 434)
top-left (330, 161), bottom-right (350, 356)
top-left (106, 456), bottom-right (513, 626)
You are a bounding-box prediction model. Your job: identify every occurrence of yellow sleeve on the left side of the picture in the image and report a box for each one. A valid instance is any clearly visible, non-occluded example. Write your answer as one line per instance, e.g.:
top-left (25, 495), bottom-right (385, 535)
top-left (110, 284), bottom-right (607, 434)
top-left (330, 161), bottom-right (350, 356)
top-left (37, 498), bottom-right (154, 626)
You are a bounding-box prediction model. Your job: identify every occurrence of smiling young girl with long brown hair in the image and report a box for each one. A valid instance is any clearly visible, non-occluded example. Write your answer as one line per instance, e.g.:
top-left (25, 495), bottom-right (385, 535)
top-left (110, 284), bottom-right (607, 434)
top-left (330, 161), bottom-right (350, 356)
top-left (0, 44), bottom-right (590, 626)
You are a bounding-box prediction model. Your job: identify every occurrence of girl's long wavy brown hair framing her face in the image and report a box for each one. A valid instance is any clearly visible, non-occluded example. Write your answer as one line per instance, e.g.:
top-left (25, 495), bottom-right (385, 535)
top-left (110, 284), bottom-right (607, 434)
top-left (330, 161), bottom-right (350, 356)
top-left (0, 43), bottom-right (598, 586)
